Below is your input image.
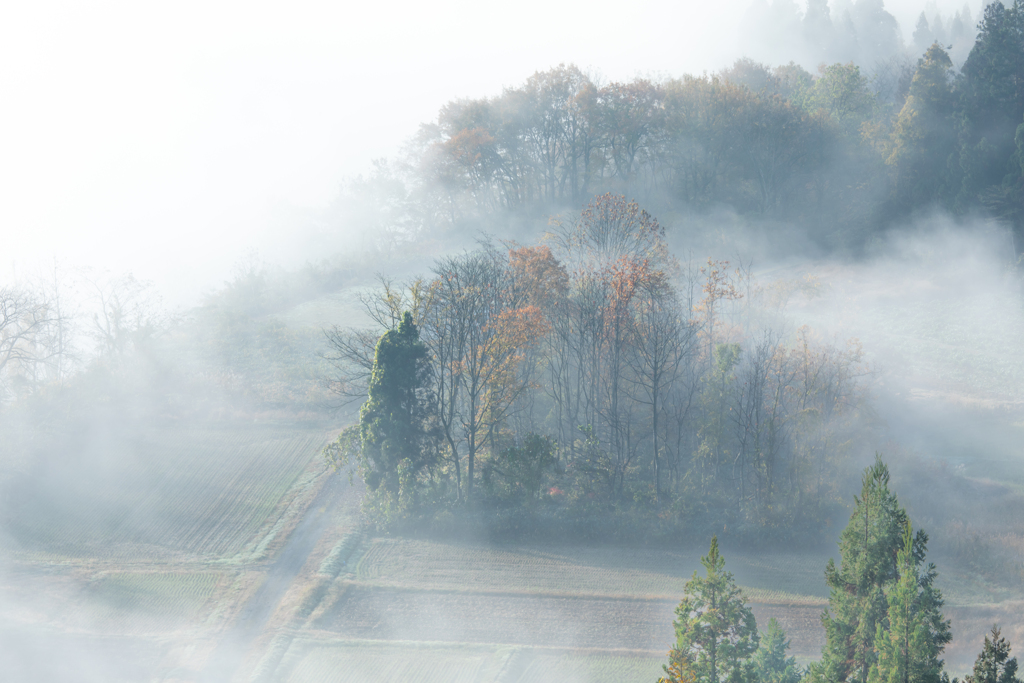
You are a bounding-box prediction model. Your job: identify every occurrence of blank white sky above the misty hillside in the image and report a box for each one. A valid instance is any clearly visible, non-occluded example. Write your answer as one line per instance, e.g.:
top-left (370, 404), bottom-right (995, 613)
top-left (0, 0), bottom-right (977, 299)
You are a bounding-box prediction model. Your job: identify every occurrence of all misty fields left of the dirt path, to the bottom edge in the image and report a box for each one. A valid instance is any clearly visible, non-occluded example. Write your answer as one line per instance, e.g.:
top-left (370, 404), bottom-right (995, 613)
top-left (0, 424), bottom-right (343, 683)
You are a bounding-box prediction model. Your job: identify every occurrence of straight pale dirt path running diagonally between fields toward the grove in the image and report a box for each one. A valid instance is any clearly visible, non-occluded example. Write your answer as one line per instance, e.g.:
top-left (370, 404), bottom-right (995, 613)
top-left (201, 472), bottom-right (349, 683)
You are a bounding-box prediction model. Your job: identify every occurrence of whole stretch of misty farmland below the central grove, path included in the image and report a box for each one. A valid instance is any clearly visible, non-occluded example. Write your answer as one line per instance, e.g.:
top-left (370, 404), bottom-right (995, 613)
top-left (0, 417), bottom-right (1024, 683)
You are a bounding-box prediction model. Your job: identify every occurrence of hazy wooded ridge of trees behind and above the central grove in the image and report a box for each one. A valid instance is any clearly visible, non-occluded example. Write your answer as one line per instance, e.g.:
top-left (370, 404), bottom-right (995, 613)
top-left (348, 0), bottom-right (1024, 253)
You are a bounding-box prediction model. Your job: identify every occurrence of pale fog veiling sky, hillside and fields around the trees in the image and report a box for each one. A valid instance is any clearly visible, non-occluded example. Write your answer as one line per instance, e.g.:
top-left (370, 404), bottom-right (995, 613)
top-left (0, 0), bottom-right (1024, 683)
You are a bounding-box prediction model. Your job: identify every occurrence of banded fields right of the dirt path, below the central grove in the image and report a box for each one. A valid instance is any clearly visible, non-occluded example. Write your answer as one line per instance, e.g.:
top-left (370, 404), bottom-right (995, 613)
top-left (253, 539), bottom-right (1024, 681)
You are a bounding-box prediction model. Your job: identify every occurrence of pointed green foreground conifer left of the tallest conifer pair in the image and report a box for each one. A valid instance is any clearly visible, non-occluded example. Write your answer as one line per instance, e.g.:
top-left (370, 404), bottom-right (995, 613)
top-left (666, 537), bottom-right (759, 683)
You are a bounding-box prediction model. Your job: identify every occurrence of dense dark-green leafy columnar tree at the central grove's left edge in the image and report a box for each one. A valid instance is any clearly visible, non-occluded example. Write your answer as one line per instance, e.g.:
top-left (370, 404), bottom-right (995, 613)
top-left (359, 312), bottom-right (432, 496)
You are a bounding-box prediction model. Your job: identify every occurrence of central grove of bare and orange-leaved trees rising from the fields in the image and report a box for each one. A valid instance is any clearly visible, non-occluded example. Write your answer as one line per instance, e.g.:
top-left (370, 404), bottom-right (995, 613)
top-left (329, 195), bottom-right (866, 537)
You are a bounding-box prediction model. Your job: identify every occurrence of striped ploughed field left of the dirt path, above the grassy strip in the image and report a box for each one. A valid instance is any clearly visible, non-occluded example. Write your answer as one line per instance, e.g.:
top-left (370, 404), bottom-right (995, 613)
top-left (8, 427), bottom-right (324, 562)
